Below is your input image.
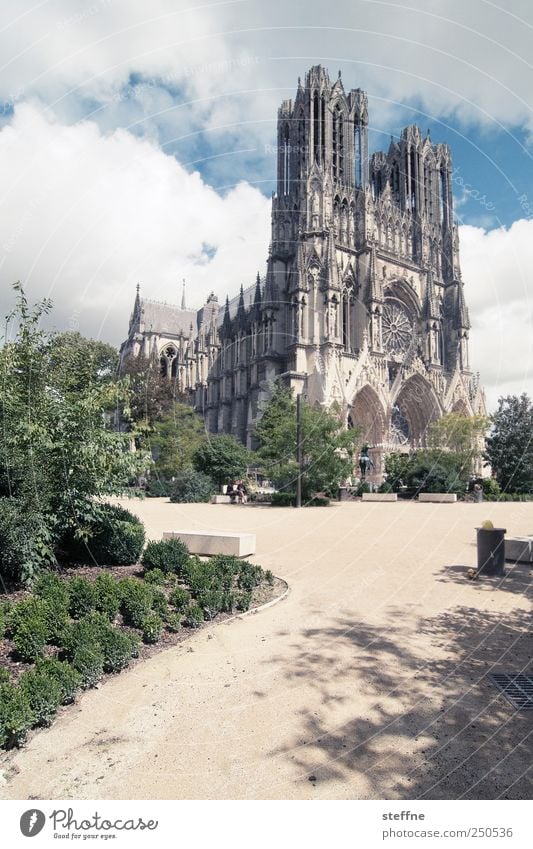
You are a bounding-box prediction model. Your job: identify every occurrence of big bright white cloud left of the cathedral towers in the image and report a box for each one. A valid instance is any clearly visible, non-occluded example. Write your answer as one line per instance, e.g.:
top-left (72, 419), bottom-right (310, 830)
top-left (0, 104), bottom-right (270, 343)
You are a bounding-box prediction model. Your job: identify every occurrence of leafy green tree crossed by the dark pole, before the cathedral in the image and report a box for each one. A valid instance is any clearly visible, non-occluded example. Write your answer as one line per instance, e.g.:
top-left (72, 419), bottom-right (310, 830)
top-left (255, 381), bottom-right (360, 498)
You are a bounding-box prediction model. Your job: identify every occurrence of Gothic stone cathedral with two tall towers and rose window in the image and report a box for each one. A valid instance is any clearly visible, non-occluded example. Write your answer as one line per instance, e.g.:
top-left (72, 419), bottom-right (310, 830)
top-left (121, 66), bottom-right (485, 477)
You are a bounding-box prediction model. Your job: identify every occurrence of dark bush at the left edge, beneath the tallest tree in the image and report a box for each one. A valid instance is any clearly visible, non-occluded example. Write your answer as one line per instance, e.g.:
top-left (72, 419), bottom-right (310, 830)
top-left (0, 498), bottom-right (55, 583)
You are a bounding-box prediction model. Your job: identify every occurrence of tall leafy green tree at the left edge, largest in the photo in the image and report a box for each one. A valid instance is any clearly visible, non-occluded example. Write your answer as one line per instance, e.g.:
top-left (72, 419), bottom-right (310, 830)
top-left (0, 284), bottom-right (149, 577)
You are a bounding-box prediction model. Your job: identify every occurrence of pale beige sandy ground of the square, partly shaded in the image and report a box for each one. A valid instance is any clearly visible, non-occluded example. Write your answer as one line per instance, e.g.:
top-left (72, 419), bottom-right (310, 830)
top-left (0, 500), bottom-right (533, 799)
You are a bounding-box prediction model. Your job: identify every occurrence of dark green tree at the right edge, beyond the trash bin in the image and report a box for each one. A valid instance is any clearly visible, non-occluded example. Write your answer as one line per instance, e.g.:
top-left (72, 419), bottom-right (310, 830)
top-left (484, 392), bottom-right (533, 493)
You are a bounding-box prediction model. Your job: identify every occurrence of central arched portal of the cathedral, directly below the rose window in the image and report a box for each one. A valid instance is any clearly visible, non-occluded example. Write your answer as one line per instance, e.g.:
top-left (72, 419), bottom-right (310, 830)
top-left (391, 374), bottom-right (442, 447)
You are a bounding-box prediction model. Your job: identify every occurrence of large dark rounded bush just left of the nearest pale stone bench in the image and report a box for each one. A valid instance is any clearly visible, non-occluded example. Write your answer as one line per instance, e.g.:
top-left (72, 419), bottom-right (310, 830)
top-left (62, 504), bottom-right (145, 566)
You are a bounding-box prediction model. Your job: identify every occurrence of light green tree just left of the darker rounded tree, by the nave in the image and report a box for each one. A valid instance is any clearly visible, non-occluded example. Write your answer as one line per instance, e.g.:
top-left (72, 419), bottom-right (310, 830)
top-left (149, 402), bottom-right (206, 479)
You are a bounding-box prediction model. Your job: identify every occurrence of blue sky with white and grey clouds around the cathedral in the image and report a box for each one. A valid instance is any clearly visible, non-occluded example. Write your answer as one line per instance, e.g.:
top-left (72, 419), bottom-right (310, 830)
top-left (0, 0), bottom-right (533, 407)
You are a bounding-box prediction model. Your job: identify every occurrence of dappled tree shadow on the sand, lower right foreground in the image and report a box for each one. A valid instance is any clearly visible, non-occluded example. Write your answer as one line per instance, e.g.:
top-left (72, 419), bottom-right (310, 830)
top-left (272, 607), bottom-right (533, 799)
